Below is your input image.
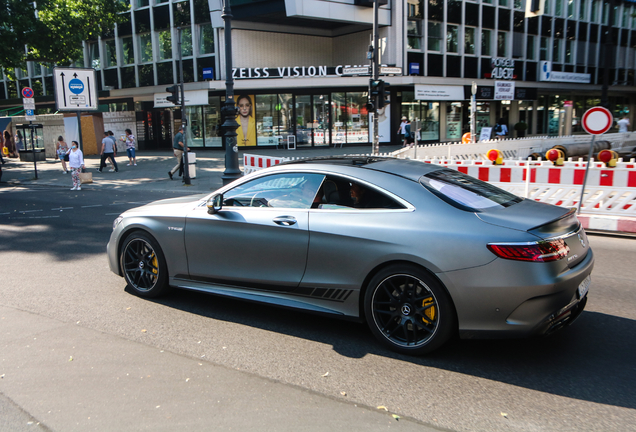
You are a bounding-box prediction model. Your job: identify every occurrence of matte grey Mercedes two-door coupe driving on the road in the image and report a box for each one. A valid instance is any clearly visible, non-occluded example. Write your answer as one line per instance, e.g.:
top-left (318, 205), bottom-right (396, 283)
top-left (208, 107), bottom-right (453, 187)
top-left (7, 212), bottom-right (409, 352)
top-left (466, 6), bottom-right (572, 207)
top-left (107, 156), bottom-right (594, 355)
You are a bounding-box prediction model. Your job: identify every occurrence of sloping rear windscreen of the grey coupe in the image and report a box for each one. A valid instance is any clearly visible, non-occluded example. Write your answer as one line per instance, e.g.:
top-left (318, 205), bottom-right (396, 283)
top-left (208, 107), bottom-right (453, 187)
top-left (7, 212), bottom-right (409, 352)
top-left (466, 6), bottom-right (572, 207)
top-left (420, 169), bottom-right (523, 211)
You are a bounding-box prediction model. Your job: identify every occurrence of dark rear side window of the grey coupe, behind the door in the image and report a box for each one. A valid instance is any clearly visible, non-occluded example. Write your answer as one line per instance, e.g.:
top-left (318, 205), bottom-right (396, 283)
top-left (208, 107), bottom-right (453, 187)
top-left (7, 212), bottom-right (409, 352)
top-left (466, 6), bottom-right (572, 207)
top-left (319, 176), bottom-right (404, 209)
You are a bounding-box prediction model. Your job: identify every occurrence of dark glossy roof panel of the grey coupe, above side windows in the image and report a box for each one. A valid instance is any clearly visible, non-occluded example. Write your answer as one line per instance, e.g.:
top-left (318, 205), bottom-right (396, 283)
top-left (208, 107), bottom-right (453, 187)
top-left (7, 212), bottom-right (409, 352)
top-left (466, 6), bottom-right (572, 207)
top-left (279, 155), bottom-right (444, 181)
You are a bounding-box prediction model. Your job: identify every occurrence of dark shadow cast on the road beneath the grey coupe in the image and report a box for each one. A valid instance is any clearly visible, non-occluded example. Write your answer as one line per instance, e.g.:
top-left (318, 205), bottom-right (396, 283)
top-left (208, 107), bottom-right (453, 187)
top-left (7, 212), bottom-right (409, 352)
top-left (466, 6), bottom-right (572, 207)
top-left (134, 289), bottom-right (636, 409)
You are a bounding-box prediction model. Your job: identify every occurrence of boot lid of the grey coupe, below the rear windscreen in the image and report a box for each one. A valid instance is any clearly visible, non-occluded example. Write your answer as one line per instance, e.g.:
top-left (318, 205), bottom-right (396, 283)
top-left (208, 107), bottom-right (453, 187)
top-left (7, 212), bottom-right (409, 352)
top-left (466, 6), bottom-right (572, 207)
top-left (476, 199), bottom-right (578, 237)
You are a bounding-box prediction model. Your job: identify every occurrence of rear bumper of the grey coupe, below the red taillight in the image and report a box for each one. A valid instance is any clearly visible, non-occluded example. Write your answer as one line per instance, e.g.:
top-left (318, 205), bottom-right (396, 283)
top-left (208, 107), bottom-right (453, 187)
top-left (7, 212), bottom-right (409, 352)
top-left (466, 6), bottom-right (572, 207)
top-left (447, 246), bottom-right (594, 339)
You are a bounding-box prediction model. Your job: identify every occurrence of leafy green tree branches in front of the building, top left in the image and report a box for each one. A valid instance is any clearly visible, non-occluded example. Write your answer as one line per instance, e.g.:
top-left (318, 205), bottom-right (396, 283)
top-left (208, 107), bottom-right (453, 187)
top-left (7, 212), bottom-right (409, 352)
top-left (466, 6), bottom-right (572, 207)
top-left (0, 0), bottom-right (129, 77)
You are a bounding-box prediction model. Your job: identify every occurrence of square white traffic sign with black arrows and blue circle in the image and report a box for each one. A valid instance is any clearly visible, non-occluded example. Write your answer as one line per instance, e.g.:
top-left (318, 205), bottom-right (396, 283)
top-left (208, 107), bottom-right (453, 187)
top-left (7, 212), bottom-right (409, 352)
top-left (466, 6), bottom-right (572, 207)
top-left (53, 67), bottom-right (98, 111)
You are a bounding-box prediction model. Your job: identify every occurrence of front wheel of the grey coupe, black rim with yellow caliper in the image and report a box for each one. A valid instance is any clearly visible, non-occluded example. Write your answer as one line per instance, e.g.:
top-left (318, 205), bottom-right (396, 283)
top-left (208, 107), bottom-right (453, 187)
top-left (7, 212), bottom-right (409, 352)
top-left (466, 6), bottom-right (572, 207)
top-left (120, 231), bottom-right (168, 297)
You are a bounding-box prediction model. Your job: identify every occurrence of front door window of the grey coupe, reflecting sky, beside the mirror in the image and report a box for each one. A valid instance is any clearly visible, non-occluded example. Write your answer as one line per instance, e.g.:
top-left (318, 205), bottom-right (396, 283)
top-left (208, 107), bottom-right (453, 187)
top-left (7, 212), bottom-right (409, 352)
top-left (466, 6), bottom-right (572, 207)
top-left (223, 173), bottom-right (325, 209)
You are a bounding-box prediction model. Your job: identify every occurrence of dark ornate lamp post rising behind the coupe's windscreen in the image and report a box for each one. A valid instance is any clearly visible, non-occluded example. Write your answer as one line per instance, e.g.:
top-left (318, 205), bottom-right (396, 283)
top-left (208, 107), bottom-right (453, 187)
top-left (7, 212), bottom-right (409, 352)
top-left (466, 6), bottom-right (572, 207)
top-left (221, 0), bottom-right (241, 185)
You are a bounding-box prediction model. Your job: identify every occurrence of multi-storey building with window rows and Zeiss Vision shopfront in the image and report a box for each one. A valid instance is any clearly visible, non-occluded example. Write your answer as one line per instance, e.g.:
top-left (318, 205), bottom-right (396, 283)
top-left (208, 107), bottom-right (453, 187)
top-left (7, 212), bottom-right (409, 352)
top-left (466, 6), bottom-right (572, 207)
top-left (0, 0), bottom-right (636, 149)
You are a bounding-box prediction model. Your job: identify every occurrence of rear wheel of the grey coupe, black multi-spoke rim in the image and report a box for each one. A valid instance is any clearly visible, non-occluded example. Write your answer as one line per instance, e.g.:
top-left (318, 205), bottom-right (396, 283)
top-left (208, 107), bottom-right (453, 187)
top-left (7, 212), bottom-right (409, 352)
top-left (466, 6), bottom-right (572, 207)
top-left (364, 265), bottom-right (456, 355)
